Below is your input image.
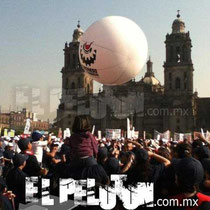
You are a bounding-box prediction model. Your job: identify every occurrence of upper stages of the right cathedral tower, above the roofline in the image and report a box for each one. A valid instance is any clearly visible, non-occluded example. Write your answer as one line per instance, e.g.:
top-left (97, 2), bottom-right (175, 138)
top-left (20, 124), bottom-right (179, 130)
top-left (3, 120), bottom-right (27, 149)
top-left (163, 10), bottom-right (194, 95)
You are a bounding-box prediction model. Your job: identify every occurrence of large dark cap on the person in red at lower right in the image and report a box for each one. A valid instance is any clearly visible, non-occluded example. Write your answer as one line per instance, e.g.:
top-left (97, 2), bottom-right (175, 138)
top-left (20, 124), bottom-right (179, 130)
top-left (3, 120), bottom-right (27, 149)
top-left (175, 157), bottom-right (204, 186)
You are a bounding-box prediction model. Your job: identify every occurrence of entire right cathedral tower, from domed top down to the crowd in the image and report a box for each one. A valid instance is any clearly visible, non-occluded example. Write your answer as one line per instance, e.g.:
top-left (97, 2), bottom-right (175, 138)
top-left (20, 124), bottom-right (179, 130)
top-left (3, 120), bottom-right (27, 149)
top-left (163, 10), bottom-right (196, 132)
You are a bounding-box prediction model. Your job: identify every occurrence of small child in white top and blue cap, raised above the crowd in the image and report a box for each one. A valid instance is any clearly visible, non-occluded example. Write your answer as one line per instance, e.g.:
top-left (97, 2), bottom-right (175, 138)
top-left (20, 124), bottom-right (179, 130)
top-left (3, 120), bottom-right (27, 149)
top-left (31, 131), bottom-right (48, 165)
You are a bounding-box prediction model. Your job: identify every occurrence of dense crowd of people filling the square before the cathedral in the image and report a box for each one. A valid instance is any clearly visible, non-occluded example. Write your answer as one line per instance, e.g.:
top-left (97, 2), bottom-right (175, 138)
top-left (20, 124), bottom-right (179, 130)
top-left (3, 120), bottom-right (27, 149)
top-left (0, 116), bottom-right (210, 210)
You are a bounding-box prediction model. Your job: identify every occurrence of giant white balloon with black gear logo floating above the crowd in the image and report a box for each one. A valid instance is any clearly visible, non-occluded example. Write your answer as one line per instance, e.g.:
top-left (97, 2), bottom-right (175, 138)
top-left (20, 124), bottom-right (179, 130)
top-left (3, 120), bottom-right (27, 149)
top-left (79, 16), bottom-right (148, 85)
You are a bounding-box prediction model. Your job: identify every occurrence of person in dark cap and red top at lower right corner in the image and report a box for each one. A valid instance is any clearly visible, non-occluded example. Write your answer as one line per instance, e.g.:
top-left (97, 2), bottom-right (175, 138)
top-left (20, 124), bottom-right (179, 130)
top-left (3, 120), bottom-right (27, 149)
top-left (173, 157), bottom-right (210, 209)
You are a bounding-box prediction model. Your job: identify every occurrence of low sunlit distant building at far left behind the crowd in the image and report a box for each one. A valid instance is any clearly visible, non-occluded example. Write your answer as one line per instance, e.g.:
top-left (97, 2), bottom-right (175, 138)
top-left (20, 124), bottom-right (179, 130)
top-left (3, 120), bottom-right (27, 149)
top-left (0, 109), bottom-right (49, 130)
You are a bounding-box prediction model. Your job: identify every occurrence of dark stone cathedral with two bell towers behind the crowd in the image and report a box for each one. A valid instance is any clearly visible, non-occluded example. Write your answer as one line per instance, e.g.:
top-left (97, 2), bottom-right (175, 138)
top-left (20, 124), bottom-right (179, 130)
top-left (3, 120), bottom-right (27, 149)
top-left (57, 14), bottom-right (210, 136)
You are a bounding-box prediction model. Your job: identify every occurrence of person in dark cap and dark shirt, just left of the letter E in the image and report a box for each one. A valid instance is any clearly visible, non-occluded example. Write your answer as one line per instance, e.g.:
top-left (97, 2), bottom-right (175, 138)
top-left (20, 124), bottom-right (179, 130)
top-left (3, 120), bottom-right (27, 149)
top-left (6, 154), bottom-right (28, 210)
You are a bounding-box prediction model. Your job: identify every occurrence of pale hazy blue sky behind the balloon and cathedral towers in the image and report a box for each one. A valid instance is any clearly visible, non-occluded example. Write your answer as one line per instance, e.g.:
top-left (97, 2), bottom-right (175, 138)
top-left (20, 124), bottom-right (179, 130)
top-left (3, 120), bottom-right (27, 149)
top-left (0, 0), bottom-right (210, 119)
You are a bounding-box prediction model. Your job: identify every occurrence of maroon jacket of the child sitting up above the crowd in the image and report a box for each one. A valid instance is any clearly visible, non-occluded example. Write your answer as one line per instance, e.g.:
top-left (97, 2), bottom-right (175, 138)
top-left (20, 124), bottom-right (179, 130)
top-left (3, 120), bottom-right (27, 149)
top-left (69, 132), bottom-right (98, 160)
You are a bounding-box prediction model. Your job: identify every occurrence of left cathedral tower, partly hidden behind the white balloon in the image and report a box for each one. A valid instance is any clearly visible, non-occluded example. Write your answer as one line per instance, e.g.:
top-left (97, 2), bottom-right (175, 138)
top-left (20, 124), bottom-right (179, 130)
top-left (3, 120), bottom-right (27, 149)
top-left (57, 21), bottom-right (93, 129)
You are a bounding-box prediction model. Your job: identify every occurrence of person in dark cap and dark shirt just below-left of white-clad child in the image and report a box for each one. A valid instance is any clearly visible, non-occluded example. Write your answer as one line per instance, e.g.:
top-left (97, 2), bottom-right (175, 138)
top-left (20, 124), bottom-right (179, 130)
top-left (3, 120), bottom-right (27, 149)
top-left (18, 138), bottom-right (47, 176)
